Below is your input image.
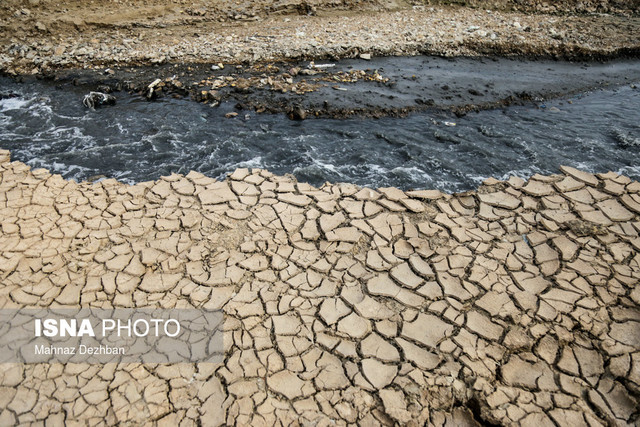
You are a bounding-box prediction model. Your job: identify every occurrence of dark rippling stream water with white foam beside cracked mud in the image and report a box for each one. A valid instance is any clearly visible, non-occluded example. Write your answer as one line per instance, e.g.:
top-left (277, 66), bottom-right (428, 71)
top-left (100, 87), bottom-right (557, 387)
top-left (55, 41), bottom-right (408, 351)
top-left (0, 71), bottom-right (640, 192)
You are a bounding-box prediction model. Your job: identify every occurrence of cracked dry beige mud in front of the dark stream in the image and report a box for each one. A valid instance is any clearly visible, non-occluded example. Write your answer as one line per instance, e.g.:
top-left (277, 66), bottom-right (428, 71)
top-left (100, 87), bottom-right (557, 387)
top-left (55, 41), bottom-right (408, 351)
top-left (0, 146), bottom-right (640, 427)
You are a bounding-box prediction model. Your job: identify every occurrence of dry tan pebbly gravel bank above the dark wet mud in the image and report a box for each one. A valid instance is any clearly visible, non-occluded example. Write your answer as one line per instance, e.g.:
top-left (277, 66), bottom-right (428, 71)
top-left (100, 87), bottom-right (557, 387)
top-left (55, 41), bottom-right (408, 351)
top-left (0, 0), bottom-right (640, 75)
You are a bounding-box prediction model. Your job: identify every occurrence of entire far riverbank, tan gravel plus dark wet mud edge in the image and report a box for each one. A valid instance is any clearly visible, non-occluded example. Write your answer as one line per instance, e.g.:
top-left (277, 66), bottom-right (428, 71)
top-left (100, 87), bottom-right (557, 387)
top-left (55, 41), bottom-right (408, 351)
top-left (0, 1), bottom-right (640, 120)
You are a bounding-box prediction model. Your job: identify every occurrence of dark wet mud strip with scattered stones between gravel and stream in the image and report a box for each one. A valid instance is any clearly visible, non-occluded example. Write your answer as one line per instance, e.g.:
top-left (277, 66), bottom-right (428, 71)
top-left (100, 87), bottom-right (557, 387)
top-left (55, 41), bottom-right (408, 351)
top-left (5, 56), bottom-right (640, 120)
